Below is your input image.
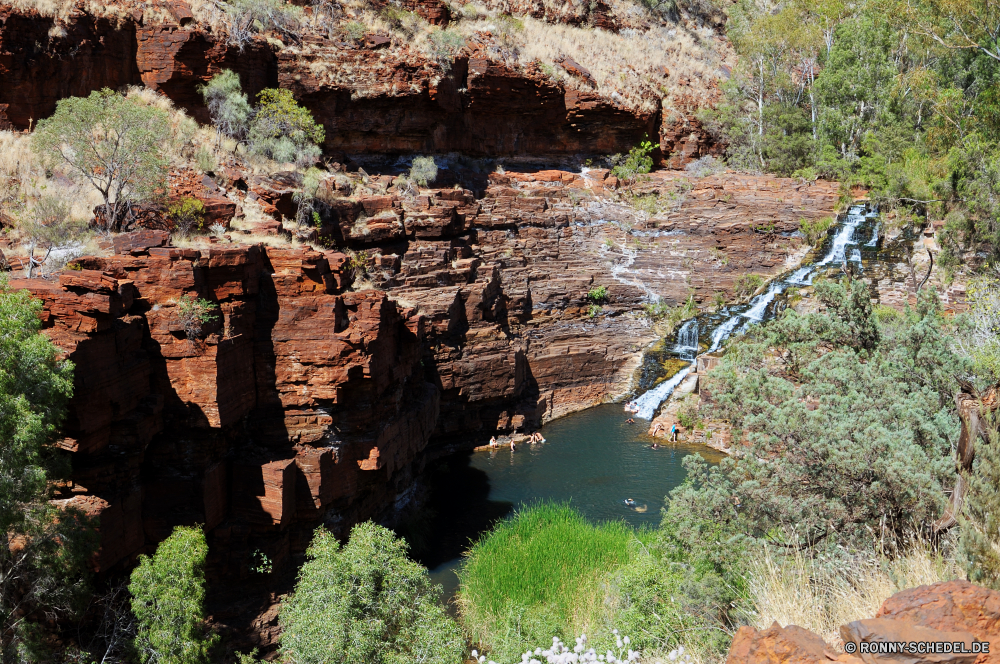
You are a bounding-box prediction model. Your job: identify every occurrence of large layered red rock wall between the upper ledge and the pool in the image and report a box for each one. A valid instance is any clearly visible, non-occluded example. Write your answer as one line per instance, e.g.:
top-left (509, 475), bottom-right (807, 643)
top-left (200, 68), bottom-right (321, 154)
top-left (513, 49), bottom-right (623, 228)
top-left (12, 163), bottom-right (836, 644)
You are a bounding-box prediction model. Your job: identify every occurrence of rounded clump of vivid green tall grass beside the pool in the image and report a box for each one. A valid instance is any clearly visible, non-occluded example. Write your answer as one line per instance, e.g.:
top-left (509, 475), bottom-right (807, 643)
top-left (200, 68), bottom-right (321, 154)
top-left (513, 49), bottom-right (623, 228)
top-left (459, 504), bottom-right (637, 661)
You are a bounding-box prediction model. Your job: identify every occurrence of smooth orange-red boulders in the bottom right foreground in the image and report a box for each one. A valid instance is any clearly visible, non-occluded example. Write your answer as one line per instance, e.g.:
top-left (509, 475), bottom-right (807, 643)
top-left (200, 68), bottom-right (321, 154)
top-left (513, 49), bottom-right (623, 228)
top-left (726, 581), bottom-right (1000, 664)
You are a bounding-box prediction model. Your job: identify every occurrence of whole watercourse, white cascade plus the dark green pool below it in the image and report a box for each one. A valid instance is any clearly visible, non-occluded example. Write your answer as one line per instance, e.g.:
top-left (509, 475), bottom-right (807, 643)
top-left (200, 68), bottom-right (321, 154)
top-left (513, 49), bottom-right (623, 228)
top-left (410, 206), bottom-right (916, 597)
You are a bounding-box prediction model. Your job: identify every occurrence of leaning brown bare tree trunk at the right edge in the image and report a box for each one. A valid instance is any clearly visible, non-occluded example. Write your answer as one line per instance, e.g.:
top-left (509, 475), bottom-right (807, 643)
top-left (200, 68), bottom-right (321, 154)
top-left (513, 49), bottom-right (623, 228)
top-left (931, 379), bottom-right (1000, 534)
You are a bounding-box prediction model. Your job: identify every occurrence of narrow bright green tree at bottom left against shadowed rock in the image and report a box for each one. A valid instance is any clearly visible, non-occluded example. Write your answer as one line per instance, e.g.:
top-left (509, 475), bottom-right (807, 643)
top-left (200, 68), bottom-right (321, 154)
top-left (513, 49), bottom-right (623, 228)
top-left (129, 526), bottom-right (215, 664)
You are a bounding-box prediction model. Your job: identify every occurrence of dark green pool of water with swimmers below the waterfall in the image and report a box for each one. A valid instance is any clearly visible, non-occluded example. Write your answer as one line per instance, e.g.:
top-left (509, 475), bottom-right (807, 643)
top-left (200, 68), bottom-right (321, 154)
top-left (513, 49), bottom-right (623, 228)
top-left (411, 405), bottom-right (719, 596)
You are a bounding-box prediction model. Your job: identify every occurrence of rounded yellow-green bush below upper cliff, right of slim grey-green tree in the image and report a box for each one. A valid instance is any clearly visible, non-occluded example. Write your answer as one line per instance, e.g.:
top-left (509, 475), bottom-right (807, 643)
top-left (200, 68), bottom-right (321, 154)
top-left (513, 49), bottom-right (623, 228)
top-left (248, 88), bottom-right (325, 164)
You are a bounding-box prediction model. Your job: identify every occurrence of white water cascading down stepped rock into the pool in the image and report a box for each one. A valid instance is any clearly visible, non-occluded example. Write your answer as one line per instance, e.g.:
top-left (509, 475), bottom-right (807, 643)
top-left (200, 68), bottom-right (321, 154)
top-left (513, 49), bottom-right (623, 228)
top-left (635, 206), bottom-right (878, 420)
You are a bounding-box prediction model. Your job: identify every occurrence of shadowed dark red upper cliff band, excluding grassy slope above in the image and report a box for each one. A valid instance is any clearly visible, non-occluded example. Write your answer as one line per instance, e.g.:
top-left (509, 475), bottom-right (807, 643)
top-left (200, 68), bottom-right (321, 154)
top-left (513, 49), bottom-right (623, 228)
top-left (0, 1), bottom-right (704, 161)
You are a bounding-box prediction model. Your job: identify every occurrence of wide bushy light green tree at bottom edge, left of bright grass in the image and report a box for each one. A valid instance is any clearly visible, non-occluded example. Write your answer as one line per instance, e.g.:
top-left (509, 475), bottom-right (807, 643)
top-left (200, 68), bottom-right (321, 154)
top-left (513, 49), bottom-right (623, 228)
top-left (280, 522), bottom-right (464, 664)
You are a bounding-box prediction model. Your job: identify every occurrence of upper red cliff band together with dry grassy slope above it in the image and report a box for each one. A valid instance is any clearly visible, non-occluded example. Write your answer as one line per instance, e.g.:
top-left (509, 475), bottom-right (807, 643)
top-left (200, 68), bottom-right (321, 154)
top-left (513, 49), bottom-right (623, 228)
top-left (0, 0), bottom-right (733, 166)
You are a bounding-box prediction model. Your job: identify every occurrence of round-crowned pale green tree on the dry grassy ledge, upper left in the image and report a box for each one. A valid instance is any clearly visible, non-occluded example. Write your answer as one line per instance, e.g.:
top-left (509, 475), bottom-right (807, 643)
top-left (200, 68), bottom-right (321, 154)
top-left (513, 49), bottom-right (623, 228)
top-left (32, 88), bottom-right (172, 231)
